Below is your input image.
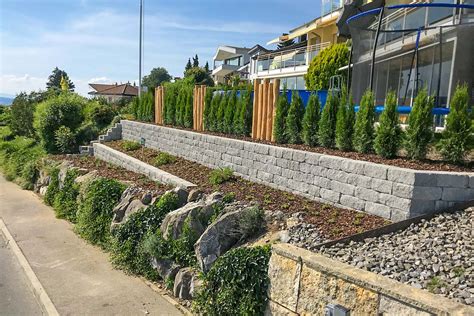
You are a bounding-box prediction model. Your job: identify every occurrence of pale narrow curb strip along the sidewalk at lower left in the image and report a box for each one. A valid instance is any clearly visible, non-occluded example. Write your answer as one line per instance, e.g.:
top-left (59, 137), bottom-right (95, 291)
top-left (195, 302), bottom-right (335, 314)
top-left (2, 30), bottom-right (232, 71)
top-left (0, 217), bottom-right (59, 316)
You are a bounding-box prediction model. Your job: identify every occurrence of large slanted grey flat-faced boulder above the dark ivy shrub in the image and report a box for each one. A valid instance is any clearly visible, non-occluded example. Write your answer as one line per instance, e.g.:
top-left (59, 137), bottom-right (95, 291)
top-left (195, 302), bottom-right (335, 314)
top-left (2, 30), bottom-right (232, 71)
top-left (194, 207), bottom-right (252, 272)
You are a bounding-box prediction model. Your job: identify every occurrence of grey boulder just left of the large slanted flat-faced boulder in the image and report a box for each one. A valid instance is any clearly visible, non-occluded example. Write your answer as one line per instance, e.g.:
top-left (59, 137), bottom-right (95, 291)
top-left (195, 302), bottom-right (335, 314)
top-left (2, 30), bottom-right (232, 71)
top-left (160, 193), bottom-right (222, 239)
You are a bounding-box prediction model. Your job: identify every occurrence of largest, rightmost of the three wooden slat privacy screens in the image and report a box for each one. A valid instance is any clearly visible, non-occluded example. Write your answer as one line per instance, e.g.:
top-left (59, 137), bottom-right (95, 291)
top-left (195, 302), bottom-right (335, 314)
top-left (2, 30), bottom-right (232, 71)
top-left (252, 79), bottom-right (280, 141)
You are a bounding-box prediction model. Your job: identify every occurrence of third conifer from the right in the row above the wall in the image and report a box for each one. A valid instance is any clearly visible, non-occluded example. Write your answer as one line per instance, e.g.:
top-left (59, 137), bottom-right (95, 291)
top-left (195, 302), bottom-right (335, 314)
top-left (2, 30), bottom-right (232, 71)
top-left (374, 91), bottom-right (402, 158)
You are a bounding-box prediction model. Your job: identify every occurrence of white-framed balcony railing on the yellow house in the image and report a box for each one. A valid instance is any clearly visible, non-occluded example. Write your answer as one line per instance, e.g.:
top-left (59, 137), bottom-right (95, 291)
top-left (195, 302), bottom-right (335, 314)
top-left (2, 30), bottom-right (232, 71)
top-left (256, 42), bottom-right (331, 73)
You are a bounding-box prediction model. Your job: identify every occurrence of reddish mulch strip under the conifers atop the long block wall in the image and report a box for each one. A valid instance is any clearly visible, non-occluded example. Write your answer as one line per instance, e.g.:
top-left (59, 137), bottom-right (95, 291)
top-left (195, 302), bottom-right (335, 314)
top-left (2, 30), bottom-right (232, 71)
top-left (142, 122), bottom-right (474, 172)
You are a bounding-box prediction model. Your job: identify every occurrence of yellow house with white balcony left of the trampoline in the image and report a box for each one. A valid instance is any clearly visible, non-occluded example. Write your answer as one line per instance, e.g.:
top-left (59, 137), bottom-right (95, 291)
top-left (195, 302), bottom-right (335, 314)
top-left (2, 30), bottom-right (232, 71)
top-left (249, 0), bottom-right (345, 90)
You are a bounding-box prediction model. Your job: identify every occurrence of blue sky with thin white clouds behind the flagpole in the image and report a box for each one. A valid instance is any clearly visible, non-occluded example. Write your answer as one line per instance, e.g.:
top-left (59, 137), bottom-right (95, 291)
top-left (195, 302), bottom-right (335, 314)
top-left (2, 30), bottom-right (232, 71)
top-left (0, 0), bottom-right (320, 95)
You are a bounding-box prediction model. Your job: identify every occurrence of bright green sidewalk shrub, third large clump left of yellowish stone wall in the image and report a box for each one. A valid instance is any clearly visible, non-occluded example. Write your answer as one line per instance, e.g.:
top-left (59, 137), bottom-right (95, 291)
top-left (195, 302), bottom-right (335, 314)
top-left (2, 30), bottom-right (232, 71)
top-left (75, 178), bottom-right (125, 248)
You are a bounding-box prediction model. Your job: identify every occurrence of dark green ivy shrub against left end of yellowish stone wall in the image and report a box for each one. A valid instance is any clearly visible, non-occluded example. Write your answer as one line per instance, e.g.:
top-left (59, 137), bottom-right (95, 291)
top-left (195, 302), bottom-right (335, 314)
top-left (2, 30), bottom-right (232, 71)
top-left (193, 247), bottom-right (270, 316)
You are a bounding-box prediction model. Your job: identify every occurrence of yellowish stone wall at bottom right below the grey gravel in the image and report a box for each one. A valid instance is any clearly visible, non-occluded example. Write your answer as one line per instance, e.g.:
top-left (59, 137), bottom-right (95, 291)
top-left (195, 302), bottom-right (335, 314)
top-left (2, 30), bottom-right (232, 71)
top-left (266, 244), bottom-right (474, 315)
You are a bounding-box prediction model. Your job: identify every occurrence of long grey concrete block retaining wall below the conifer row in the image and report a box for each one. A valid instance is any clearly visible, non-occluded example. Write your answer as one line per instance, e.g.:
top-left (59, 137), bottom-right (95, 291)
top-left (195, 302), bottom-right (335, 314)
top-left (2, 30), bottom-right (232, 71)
top-left (121, 120), bottom-right (474, 221)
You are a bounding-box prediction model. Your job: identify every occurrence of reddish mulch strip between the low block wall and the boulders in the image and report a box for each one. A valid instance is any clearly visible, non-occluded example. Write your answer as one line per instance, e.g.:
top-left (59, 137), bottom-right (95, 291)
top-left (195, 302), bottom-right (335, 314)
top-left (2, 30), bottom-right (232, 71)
top-left (51, 155), bottom-right (171, 194)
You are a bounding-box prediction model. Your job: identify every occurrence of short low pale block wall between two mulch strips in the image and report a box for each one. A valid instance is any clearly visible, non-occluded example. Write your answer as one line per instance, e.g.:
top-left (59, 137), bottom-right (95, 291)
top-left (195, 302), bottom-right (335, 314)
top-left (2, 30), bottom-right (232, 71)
top-left (93, 143), bottom-right (196, 188)
